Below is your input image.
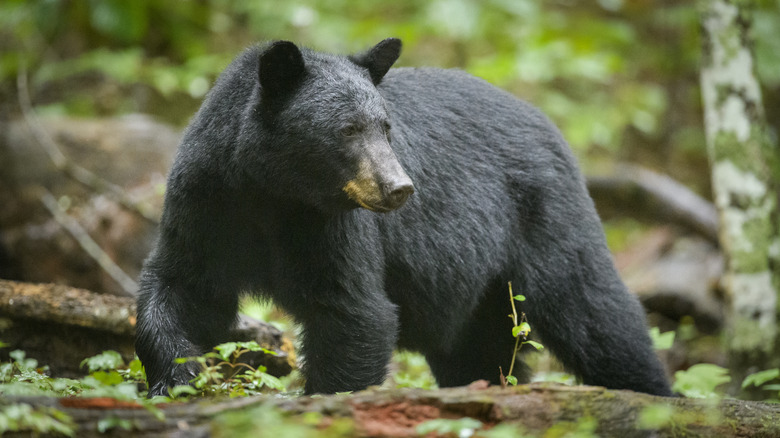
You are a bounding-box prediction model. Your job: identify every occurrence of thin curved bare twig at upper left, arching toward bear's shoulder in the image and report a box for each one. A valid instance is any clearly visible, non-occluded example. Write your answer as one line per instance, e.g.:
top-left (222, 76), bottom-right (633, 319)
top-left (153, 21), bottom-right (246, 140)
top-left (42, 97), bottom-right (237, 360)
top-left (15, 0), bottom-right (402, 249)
top-left (16, 64), bottom-right (159, 224)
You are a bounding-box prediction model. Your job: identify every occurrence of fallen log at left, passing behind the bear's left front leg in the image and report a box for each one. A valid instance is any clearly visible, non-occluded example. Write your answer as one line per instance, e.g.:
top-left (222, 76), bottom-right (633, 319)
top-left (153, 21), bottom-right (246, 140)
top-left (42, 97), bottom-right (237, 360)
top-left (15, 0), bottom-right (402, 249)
top-left (0, 280), bottom-right (295, 377)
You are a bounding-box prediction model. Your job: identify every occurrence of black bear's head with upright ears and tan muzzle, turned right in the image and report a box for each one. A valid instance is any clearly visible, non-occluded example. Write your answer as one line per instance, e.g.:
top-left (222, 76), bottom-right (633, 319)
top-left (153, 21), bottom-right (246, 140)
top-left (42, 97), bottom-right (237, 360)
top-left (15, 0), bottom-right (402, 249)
top-left (247, 39), bottom-right (414, 212)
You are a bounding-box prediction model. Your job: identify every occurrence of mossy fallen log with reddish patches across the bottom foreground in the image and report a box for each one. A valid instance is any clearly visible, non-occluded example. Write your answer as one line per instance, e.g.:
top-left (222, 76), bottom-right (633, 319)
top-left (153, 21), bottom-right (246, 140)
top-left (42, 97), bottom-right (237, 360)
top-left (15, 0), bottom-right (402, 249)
top-left (4, 382), bottom-right (780, 438)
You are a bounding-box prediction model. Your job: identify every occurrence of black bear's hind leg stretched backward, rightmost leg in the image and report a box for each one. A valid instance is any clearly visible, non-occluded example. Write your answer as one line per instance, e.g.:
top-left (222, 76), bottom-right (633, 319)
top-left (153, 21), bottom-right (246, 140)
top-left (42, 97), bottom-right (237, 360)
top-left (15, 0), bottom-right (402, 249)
top-left (523, 253), bottom-right (671, 396)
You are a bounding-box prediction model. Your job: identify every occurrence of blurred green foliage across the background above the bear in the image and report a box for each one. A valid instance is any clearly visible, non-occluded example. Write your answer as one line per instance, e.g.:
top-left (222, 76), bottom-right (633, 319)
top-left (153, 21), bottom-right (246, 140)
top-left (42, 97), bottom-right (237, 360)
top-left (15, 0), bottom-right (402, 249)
top-left (0, 0), bottom-right (780, 155)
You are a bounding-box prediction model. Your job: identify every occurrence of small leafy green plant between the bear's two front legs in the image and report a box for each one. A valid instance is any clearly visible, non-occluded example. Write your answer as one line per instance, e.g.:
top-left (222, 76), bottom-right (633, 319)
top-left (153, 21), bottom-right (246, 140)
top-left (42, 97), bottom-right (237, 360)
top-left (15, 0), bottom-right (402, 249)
top-left (171, 341), bottom-right (285, 398)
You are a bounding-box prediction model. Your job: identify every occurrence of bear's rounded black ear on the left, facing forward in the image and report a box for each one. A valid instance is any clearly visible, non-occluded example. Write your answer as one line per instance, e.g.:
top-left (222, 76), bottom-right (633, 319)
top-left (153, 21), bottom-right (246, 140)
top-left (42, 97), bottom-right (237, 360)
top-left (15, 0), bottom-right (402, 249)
top-left (258, 41), bottom-right (306, 100)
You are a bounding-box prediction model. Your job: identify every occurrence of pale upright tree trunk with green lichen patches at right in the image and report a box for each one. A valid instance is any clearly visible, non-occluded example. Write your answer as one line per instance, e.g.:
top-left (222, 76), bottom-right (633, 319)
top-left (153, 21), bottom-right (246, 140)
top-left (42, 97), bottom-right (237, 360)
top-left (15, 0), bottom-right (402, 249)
top-left (700, 0), bottom-right (780, 396)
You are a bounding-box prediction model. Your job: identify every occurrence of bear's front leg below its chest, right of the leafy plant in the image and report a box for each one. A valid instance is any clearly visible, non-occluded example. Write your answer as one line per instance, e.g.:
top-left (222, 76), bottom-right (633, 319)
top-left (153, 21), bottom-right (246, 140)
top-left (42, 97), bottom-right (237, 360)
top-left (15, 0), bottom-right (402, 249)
top-left (298, 296), bottom-right (398, 394)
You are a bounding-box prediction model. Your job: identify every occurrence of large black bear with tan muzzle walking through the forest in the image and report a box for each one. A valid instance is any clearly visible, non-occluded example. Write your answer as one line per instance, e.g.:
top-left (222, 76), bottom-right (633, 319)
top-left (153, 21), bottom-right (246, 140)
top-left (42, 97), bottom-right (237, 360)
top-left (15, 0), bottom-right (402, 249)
top-left (136, 39), bottom-right (670, 396)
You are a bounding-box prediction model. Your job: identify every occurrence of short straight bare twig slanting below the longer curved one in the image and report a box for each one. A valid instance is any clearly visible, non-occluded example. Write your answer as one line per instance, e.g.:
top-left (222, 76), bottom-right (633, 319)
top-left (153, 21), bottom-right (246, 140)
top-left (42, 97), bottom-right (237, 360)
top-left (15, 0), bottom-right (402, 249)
top-left (40, 187), bottom-right (138, 296)
